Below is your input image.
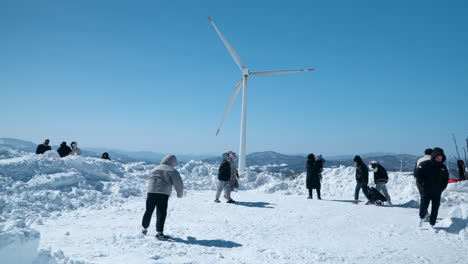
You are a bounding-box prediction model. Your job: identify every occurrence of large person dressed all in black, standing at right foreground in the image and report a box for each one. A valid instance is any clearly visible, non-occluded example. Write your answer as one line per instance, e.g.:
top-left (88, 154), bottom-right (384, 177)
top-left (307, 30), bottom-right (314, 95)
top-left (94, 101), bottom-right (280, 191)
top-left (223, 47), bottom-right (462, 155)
top-left (416, 148), bottom-right (449, 228)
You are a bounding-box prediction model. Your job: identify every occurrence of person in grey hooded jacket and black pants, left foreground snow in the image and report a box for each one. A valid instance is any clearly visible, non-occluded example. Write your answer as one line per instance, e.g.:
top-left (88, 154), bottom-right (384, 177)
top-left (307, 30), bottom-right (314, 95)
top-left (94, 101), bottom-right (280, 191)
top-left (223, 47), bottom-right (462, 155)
top-left (141, 155), bottom-right (184, 240)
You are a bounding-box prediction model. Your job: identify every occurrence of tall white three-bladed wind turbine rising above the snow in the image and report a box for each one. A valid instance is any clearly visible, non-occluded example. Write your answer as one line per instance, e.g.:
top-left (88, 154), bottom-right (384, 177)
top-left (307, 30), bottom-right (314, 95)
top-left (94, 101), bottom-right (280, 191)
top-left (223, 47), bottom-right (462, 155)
top-left (208, 17), bottom-right (314, 176)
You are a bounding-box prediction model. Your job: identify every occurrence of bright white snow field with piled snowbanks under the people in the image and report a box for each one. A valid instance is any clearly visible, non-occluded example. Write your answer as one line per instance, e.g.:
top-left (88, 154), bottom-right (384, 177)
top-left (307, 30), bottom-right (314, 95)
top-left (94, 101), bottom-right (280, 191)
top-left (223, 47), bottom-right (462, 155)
top-left (0, 150), bottom-right (468, 264)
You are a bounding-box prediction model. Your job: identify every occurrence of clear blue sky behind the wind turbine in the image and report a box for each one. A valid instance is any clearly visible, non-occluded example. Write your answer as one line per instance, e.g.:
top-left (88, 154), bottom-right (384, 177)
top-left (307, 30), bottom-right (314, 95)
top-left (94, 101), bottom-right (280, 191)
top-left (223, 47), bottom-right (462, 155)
top-left (0, 0), bottom-right (468, 155)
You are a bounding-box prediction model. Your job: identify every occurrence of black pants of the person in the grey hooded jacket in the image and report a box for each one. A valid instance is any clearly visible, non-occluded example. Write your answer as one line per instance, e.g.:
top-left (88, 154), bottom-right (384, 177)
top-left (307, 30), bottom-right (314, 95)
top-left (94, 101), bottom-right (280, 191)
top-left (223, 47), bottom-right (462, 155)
top-left (141, 193), bottom-right (169, 232)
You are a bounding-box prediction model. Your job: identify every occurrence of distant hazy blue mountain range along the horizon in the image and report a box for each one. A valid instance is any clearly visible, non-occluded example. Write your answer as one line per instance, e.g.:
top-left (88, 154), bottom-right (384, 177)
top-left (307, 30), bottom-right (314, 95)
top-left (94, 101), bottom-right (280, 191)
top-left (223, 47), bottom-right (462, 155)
top-left (0, 138), bottom-right (456, 173)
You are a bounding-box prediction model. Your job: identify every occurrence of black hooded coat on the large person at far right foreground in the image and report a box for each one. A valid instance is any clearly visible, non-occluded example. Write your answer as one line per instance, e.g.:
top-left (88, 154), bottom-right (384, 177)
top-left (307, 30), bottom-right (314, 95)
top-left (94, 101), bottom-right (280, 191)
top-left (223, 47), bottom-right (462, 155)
top-left (416, 148), bottom-right (449, 195)
